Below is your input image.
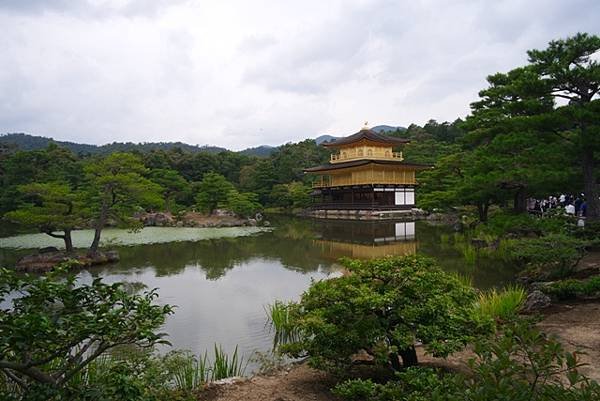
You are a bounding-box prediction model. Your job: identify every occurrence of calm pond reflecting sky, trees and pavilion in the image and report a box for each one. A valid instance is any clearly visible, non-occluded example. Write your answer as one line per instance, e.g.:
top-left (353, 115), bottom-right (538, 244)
top-left (0, 217), bottom-right (514, 373)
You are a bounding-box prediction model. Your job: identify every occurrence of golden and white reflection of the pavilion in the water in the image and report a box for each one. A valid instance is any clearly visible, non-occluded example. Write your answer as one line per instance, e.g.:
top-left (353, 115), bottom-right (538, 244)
top-left (314, 220), bottom-right (417, 259)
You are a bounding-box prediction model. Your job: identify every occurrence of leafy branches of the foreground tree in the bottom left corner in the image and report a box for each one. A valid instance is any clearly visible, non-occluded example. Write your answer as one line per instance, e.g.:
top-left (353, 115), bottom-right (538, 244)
top-left (0, 269), bottom-right (172, 399)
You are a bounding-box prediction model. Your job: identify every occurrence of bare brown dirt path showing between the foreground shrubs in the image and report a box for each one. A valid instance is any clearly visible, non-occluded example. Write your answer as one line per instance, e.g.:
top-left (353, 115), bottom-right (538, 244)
top-left (198, 302), bottom-right (600, 401)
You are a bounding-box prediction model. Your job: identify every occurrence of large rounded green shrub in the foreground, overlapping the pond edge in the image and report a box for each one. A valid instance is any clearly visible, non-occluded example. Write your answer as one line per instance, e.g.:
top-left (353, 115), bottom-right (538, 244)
top-left (280, 256), bottom-right (489, 371)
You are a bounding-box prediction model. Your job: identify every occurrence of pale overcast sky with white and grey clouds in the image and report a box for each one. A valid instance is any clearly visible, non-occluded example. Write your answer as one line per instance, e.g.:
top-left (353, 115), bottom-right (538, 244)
top-left (0, 0), bottom-right (600, 150)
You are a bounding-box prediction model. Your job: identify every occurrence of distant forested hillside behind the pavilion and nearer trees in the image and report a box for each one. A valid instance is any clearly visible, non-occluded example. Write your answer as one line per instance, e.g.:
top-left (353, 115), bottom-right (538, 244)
top-left (0, 120), bottom-right (462, 219)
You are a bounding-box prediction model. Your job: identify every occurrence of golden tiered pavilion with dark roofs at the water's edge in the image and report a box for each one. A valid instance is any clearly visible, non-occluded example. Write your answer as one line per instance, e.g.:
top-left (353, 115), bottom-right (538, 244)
top-left (305, 125), bottom-right (428, 210)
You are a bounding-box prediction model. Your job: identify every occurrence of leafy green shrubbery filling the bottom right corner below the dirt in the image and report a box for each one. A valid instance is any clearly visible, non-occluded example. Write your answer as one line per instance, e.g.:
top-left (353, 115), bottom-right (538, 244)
top-left (333, 320), bottom-right (600, 401)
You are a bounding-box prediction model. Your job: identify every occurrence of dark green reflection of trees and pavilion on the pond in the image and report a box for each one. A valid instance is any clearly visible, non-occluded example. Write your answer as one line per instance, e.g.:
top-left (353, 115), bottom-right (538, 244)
top-left (0, 218), bottom-right (514, 288)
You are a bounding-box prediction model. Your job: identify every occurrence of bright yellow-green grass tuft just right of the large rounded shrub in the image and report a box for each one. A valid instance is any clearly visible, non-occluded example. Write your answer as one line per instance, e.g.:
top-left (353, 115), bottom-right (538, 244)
top-left (475, 285), bottom-right (526, 320)
